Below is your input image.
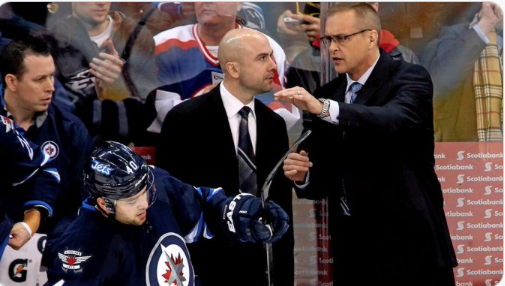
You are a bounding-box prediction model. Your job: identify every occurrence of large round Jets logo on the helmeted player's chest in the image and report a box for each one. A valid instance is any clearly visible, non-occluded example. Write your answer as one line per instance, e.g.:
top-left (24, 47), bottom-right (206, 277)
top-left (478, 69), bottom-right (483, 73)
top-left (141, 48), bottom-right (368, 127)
top-left (146, 232), bottom-right (194, 286)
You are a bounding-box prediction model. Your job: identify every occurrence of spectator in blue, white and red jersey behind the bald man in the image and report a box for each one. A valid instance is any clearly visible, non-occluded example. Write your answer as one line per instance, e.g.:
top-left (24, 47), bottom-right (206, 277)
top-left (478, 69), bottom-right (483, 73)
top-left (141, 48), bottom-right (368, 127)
top-left (146, 2), bottom-right (299, 146)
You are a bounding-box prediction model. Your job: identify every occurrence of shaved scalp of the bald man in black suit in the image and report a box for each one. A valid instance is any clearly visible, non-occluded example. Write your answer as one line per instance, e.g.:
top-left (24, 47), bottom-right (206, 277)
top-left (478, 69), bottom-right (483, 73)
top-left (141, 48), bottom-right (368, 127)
top-left (218, 29), bottom-right (268, 70)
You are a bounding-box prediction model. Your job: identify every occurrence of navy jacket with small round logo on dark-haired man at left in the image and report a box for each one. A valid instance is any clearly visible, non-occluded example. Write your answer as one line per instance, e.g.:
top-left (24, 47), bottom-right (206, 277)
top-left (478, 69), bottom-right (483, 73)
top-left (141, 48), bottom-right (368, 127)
top-left (0, 104), bottom-right (93, 256)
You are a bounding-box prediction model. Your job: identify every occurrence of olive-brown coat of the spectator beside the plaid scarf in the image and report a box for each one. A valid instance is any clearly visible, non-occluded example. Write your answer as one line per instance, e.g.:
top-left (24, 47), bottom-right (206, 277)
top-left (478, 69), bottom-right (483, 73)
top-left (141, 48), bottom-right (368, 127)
top-left (421, 23), bottom-right (486, 142)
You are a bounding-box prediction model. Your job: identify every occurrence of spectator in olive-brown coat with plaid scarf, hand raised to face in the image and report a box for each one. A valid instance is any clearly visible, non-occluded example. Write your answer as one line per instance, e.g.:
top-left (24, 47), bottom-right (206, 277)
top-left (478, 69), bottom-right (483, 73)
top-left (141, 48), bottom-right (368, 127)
top-left (421, 3), bottom-right (503, 142)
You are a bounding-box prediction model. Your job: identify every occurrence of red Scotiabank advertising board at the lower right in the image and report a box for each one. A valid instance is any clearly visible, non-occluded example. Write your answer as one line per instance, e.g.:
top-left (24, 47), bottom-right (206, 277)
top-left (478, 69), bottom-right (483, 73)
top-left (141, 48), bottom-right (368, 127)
top-left (435, 142), bottom-right (503, 286)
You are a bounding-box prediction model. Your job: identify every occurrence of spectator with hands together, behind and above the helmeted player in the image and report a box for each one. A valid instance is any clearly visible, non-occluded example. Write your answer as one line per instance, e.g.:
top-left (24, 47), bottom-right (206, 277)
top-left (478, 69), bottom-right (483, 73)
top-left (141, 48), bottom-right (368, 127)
top-left (50, 2), bottom-right (155, 143)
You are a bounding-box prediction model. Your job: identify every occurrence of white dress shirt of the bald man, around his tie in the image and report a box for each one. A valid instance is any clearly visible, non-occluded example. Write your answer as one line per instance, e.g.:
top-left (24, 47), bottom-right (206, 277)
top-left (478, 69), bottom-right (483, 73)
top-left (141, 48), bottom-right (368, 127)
top-left (219, 84), bottom-right (257, 154)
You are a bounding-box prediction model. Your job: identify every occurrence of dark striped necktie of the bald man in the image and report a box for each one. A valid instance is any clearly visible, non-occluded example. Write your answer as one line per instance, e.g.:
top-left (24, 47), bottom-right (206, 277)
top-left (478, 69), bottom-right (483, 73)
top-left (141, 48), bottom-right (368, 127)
top-left (237, 106), bottom-right (258, 195)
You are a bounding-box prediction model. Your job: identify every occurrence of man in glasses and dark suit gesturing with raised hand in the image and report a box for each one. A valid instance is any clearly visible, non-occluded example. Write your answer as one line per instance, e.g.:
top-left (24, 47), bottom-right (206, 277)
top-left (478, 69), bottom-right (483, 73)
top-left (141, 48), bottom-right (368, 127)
top-left (275, 3), bottom-right (457, 286)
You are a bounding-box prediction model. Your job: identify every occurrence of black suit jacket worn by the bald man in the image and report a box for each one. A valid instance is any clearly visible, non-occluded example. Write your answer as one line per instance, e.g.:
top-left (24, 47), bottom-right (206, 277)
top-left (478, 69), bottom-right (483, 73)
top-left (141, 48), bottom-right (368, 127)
top-left (156, 86), bottom-right (294, 286)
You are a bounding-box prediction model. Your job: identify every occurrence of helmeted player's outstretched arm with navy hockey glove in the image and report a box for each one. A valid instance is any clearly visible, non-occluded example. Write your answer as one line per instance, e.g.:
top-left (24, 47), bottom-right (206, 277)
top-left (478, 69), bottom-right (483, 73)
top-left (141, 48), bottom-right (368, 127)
top-left (158, 172), bottom-right (289, 243)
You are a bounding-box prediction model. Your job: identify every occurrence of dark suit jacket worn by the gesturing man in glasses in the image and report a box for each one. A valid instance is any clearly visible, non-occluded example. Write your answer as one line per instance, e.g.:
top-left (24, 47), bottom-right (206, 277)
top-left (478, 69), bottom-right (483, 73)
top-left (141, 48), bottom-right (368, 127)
top-left (297, 51), bottom-right (456, 285)
